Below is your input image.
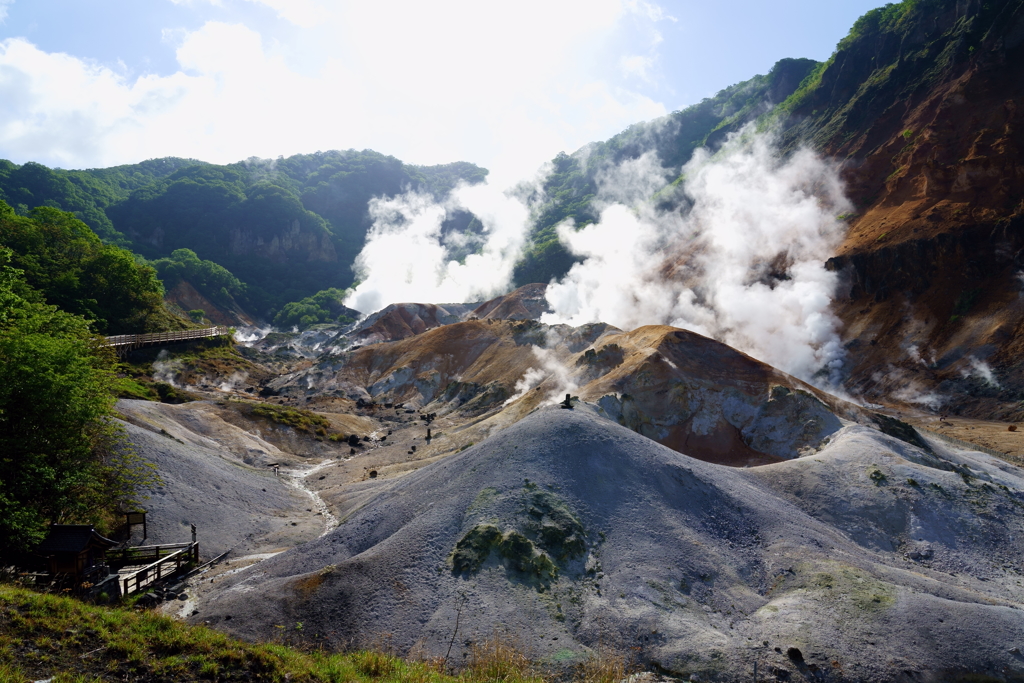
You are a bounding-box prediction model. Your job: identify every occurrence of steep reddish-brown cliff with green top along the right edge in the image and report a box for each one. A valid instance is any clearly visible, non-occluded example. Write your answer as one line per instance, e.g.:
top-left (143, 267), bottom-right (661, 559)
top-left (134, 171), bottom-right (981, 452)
top-left (782, 0), bottom-right (1024, 419)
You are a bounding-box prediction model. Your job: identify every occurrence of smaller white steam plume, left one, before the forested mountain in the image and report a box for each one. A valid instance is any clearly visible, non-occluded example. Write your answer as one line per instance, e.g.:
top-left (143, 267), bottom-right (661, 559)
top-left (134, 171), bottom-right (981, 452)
top-left (345, 178), bottom-right (529, 313)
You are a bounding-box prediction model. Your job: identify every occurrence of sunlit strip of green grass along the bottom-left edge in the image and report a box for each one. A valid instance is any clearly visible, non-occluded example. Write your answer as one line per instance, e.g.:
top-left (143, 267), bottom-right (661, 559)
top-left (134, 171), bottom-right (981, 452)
top-left (0, 585), bottom-right (598, 683)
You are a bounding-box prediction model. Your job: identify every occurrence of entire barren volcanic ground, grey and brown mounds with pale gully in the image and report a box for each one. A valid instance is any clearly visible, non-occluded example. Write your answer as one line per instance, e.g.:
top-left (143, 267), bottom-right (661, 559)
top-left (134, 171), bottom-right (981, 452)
top-left (101, 287), bottom-right (1024, 681)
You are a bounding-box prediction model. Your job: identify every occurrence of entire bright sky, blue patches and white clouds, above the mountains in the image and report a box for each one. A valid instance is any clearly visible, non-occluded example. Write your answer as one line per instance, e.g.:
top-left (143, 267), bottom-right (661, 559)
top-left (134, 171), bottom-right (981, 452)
top-left (0, 0), bottom-right (880, 177)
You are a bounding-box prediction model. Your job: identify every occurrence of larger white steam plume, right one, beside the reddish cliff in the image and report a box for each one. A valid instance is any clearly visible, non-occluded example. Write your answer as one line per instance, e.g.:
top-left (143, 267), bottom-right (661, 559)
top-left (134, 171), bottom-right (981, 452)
top-left (542, 131), bottom-right (850, 385)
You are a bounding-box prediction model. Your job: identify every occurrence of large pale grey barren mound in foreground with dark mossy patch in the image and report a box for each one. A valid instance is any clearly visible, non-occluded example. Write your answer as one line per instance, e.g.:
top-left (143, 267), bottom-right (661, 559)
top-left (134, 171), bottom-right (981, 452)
top-left (199, 405), bottom-right (1024, 681)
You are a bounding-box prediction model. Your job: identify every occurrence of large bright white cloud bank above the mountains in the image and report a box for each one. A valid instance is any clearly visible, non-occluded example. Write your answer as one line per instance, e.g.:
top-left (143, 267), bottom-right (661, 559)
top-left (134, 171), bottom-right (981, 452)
top-left (0, 0), bottom-right (667, 180)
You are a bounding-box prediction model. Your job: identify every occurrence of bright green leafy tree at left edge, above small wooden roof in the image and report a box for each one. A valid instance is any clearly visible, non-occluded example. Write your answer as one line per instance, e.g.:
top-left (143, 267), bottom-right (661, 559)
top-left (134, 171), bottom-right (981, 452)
top-left (0, 248), bottom-right (153, 554)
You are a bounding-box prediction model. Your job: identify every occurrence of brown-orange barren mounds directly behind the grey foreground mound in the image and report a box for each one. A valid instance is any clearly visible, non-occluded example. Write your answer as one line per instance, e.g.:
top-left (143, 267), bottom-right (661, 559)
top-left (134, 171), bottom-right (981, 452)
top-left (262, 311), bottom-right (891, 466)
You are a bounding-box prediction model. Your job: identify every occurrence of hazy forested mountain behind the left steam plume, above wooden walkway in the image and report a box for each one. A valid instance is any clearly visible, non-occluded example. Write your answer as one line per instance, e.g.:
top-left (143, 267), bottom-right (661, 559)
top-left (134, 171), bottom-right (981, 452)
top-left (0, 151), bottom-right (486, 316)
